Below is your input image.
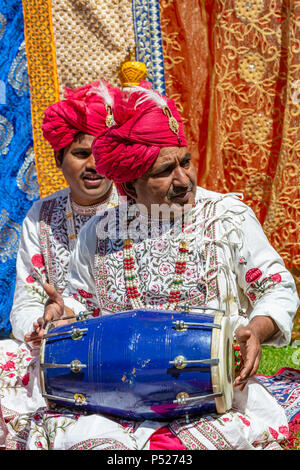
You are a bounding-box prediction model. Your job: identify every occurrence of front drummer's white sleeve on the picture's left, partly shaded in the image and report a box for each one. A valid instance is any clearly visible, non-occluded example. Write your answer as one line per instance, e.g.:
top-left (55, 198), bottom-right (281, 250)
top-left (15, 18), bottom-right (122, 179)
top-left (63, 217), bottom-right (100, 316)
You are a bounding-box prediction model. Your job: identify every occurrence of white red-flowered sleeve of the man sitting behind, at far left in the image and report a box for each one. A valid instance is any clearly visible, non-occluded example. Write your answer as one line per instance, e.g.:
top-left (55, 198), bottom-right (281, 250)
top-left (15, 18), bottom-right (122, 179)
top-left (10, 202), bottom-right (47, 341)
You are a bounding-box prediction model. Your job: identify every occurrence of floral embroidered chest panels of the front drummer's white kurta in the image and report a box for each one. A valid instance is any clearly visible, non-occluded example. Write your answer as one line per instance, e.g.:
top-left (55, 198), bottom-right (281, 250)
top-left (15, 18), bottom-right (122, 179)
top-left (94, 198), bottom-right (219, 312)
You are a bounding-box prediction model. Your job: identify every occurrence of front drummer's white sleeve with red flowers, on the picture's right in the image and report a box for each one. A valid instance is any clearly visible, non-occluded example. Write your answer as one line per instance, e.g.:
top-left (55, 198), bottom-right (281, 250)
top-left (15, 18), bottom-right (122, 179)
top-left (229, 204), bottom-right (299, 347)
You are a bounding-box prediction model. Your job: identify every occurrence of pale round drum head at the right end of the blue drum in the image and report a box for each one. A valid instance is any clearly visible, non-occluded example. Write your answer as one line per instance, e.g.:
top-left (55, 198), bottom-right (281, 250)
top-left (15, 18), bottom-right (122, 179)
top-left (211, 313), bottom-right (234, 414)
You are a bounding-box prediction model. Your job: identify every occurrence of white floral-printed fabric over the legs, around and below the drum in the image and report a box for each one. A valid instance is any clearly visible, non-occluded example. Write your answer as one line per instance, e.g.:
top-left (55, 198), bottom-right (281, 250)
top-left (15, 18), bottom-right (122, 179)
top-left (0, 341), bottom-right (288, 450)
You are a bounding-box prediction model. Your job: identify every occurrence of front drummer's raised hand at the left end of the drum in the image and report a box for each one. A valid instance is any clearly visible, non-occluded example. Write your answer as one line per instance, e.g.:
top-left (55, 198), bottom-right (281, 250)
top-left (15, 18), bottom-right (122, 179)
top-left (25, 282), bottom-right (73, 346)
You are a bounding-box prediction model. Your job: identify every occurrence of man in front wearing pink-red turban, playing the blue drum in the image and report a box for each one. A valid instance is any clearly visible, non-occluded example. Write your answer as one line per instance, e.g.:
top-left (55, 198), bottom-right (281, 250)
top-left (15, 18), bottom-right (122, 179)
top-left (2, 87), bottom-right (298, 450)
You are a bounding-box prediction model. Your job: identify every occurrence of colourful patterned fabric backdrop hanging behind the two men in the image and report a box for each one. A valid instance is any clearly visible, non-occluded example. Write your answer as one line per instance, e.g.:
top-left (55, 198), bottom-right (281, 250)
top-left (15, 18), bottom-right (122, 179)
top-left (0, 0), bottom-right (300, 336)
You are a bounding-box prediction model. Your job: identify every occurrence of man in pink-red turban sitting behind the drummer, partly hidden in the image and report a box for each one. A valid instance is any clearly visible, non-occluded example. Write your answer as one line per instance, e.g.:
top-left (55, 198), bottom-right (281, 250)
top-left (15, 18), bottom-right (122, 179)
top-left (0, 82), bottom-right (119, 450)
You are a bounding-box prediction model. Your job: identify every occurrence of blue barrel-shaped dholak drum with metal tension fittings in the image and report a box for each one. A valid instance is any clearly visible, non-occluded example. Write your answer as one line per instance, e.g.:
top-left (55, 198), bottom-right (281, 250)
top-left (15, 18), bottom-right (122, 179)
top-left (40, 310), bottom-right (234, 420)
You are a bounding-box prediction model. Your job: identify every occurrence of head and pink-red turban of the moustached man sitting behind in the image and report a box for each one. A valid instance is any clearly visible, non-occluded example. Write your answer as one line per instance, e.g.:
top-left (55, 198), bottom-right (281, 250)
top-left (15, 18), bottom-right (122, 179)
top-left (42, 81), bottom-right (120, 205)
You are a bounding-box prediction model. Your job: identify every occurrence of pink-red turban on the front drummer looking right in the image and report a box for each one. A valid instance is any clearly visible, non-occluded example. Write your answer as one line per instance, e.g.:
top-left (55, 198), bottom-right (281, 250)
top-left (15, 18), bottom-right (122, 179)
top-left (93, 84), bottom-right (187, 189)
